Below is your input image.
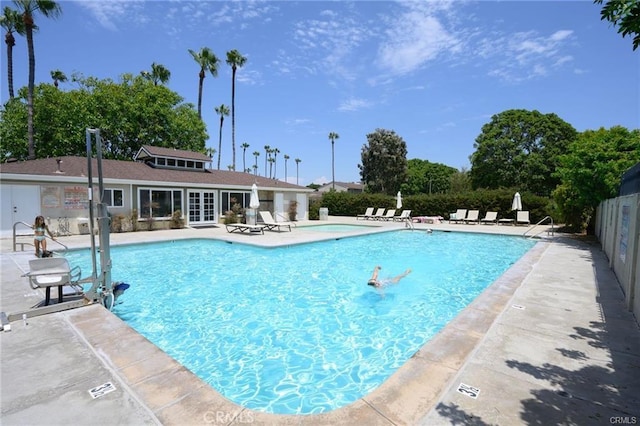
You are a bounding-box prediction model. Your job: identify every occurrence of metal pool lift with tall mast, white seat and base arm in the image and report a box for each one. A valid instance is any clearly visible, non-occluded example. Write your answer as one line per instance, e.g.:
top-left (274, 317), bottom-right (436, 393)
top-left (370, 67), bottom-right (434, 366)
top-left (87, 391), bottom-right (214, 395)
top-left (6, 129), bottom-right (121, 324)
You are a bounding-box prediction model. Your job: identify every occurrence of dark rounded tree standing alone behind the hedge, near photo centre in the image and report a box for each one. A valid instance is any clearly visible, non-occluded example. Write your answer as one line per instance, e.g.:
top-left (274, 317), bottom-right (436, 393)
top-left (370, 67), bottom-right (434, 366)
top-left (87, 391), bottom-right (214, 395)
top-left (358, 129), bottom-right (407, 195)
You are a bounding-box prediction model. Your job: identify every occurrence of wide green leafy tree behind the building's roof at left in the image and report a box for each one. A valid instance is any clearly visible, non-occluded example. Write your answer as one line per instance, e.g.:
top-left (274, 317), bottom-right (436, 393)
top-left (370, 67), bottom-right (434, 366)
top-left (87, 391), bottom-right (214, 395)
top-left (0, 74), bottom-right (207, 160)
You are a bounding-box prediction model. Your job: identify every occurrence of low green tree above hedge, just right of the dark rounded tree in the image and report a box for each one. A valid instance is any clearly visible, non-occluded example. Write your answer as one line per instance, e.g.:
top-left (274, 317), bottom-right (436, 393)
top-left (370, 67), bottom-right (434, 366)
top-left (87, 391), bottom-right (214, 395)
top-left (401, 158), bottom-right (457, 195)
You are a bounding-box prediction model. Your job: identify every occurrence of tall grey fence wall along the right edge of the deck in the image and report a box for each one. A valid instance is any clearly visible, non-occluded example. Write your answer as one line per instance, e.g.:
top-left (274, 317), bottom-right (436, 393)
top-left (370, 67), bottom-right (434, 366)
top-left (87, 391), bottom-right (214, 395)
top-left (595, 193), bottom-right (640, 320)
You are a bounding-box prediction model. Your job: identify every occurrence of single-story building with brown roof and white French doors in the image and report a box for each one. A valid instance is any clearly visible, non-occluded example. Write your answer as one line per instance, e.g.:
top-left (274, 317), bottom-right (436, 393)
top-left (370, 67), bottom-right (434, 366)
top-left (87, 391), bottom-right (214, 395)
top-left (0, 145), bottom-right (313, 238)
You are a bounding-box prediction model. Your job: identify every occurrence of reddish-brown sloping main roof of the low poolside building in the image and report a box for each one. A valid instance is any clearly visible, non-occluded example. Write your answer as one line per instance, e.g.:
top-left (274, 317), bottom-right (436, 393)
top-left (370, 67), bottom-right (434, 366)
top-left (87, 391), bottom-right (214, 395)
top-left (0, 156), bottom-right (312, 192)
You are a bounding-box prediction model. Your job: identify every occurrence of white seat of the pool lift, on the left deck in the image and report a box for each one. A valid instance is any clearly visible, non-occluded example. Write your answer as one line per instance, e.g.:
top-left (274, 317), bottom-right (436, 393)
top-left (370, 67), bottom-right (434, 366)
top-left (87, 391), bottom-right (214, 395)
top-left (26, 257), bottom-right (82, 306)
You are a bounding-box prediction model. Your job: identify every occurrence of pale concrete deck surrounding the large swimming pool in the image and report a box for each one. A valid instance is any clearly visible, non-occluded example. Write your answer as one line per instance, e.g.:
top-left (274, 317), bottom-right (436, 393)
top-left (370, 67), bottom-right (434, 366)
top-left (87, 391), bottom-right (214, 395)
top-left (0, 217), bottom-right (640, 425)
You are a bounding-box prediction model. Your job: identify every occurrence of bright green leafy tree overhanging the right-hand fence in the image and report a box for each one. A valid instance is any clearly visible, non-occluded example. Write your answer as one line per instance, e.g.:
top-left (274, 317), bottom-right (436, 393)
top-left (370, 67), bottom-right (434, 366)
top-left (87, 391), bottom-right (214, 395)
top-left (553, 126), bottom-right (640, 230)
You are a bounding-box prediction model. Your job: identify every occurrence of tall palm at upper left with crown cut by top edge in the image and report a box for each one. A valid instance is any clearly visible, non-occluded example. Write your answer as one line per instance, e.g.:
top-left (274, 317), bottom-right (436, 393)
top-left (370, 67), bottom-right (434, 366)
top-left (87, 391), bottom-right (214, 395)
top-left (13, 0), bottom-right (62, 159)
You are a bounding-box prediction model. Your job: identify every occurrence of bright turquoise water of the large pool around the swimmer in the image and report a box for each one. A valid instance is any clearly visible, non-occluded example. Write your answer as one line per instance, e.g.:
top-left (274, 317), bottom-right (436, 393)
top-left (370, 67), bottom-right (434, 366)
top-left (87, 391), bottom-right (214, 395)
top-left (63, 231), bottom-right (535, 414)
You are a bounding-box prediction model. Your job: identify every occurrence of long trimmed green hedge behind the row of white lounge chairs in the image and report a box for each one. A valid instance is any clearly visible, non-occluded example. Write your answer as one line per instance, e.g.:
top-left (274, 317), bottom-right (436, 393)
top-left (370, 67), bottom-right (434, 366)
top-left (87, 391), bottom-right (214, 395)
top-left (309, 189), bottom-right (557, 223)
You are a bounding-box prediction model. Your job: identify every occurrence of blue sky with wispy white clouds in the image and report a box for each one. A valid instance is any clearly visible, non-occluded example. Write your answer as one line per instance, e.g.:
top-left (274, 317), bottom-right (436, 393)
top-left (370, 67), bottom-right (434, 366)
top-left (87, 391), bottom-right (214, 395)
top-left (0, 0), bottom-right (640, 185)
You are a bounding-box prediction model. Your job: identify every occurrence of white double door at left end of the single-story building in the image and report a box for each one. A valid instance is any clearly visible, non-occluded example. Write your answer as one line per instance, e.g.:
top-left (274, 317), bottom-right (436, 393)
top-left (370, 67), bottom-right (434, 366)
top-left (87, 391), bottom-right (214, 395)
top-left (0, 185), bottom-right (40, 238)
